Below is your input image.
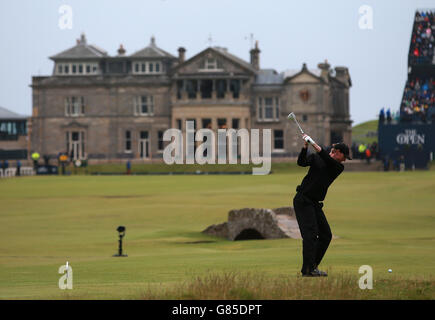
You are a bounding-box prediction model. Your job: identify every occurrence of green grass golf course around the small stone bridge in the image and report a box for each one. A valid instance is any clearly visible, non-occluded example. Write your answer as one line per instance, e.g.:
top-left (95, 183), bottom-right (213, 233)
top-left (0, 168), bottom-right (435, 299)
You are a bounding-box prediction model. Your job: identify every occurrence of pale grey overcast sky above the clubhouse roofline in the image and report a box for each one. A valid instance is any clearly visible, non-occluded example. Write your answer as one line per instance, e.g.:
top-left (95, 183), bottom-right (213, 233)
top-left (0, 0), bottom-right (435, 124)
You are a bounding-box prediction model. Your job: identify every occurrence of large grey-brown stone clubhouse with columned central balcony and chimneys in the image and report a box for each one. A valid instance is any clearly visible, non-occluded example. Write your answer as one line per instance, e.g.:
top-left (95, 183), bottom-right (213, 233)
top-left (29, 34), bottom-right (352, 163)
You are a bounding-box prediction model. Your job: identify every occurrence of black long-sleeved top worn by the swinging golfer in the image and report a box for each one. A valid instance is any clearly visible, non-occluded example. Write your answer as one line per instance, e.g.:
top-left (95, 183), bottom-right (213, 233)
top-left (296, 148), bottom-right (344, 201)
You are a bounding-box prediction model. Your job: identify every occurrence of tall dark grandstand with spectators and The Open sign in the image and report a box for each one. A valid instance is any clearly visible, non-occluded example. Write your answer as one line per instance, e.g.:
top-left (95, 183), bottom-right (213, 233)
top-left (378, 9), bottom-right (435, 169)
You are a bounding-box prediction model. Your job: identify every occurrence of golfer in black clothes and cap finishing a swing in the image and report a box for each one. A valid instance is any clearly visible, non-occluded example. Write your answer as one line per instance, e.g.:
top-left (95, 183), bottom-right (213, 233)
top-left (293, 134), bottom-right (351, 277)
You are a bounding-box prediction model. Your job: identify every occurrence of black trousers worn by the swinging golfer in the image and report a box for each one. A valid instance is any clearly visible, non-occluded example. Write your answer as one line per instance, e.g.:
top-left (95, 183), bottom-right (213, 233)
top-left (293, 192), bottom-right (332, 274)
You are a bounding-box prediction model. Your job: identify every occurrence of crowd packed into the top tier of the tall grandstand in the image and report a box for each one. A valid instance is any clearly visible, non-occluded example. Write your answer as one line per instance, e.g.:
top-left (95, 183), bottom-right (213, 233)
top-left (409, 12), bottom-right (435, 64)
